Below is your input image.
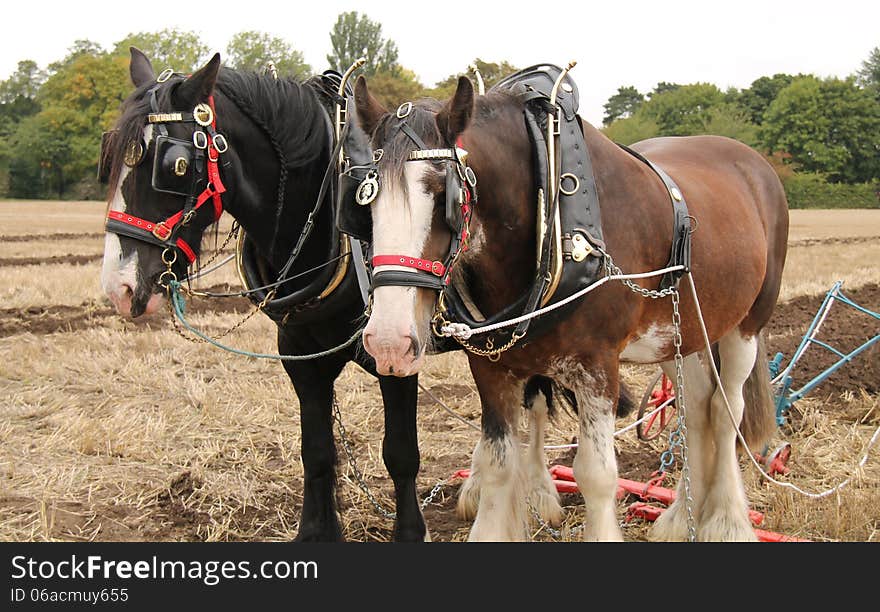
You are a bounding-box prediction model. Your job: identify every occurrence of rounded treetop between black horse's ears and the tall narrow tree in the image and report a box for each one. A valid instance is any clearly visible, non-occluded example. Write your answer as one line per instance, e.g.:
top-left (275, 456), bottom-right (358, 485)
top-left (226, 30), bottom-right (312, 80)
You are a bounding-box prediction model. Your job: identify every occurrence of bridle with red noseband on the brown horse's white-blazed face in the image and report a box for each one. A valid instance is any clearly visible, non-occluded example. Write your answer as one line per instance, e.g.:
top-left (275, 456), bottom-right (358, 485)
top-left (358, 102), bottom-right (477, 291)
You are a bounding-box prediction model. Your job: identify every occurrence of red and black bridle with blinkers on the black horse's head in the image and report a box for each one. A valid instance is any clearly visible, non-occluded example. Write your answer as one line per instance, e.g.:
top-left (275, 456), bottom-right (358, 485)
top-left (101, 71), bottom-right (229, 268)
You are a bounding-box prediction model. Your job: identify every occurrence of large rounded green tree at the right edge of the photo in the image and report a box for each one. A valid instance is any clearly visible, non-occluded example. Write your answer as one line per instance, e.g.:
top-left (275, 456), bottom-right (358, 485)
top-left (760, 76), bottom-right (880, 182)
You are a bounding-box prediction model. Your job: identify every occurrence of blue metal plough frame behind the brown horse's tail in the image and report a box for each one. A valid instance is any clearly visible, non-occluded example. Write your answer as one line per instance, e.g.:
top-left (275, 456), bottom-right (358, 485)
top-left (770, 281), bottom-right (880, 425)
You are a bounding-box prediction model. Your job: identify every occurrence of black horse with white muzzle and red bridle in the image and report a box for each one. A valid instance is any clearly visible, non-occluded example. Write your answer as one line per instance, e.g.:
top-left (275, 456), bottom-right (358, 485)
top-left (102, 48), bottom-right (426, 541)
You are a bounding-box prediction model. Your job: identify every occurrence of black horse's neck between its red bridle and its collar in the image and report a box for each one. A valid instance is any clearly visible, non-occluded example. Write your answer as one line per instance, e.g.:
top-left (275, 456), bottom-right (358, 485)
top-left (216, 87), bottom-right (330, 266)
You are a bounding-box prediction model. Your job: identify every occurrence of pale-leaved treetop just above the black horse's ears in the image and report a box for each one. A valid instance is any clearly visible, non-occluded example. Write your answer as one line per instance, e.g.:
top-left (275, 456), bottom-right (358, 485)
top-left (113, 28), bottom-right (209, 73)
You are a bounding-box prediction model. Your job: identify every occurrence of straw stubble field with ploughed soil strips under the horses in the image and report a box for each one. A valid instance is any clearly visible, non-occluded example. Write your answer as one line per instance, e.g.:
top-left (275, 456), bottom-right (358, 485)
top-left (0, 202), bottom-right (880, 541)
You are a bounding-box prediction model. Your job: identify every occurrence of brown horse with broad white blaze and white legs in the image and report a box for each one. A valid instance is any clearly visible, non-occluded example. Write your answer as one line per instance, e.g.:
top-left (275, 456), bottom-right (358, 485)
top-left (355, 78), bottom-right (788, 540)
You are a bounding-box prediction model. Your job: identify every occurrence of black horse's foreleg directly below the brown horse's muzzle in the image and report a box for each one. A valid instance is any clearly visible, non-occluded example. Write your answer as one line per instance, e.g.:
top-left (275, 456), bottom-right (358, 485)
top-left (379, 376), bottom-right (430, 542)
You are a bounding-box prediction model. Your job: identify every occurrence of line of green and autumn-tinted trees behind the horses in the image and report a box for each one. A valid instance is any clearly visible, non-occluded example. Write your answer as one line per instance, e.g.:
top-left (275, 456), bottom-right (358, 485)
top-left (0, 11), bottom-right (880, 206)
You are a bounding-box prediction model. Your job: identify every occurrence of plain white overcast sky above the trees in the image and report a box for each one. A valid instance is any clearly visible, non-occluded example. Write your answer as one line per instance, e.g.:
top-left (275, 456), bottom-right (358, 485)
top-left (0, 0), bottom-right (880, 124)
